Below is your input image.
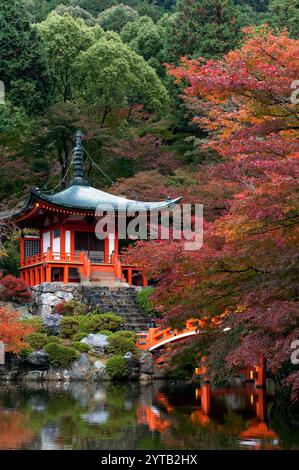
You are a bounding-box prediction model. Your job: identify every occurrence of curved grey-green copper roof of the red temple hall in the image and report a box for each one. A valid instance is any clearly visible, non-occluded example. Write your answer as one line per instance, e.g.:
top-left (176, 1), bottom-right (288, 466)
top-left (33, 184), bottom-right (181, 212)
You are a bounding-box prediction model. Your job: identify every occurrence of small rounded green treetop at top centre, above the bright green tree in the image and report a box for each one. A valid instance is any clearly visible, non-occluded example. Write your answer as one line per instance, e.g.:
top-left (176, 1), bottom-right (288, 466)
top-left (98, 3), bottom-right (139, 33)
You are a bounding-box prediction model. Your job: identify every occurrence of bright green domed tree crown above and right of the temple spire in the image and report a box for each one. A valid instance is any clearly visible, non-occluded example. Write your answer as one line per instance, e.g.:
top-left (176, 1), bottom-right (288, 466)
top-left (78, 33), bottom-right (168, 115)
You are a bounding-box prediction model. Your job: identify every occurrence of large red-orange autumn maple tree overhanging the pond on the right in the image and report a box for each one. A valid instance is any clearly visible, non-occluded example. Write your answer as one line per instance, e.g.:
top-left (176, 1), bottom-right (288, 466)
top-left (124, 27), bottom-right (299, 399)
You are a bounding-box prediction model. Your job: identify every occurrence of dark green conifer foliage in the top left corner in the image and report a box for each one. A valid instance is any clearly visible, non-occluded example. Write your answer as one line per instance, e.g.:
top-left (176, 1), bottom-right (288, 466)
top-left (0, 0), bottom-right (48, 114)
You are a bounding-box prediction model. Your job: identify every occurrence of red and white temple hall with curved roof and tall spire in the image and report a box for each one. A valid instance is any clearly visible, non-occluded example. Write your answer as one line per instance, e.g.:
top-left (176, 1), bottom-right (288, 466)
top-left (10, 132), bottom-right (180, 286)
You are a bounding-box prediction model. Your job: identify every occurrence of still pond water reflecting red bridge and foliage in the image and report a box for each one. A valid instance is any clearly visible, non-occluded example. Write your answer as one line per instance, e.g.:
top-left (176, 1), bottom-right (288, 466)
top-left (0, 382), bottom-right (299, 450)
